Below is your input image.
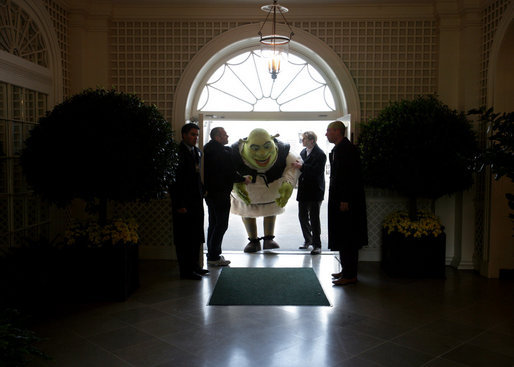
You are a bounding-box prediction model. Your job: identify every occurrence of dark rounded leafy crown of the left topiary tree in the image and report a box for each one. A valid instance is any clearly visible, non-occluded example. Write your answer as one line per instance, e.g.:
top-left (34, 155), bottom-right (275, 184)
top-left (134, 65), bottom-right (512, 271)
top-left (21, 89), bottom-right (177, 217)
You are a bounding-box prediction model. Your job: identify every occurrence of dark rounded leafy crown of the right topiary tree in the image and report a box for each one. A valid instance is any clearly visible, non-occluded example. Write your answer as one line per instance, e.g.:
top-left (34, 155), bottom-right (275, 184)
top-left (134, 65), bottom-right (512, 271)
top-left (359, 95), bottom-right (478, 199)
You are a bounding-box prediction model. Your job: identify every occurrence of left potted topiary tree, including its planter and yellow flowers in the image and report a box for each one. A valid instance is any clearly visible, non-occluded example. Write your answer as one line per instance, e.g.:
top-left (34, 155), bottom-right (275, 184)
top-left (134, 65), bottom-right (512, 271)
top-left (21, 89), bottom-right (177, 299)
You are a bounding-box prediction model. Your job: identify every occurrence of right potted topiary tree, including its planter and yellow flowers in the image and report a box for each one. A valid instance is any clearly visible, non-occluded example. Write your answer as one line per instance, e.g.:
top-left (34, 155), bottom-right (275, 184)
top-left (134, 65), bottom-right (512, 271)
top-left (358, 95), bottom-right (478, 277)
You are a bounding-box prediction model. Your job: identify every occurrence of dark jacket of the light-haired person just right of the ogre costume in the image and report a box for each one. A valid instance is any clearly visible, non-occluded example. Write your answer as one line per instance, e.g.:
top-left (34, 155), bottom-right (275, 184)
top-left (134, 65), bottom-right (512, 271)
top-left (296, 144), bottom-right (327, 201)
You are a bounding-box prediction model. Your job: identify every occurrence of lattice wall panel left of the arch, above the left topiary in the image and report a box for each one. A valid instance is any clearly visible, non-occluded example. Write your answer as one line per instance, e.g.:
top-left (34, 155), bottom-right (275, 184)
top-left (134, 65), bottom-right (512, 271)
top-left (110, 21), bottom-right (250, 121)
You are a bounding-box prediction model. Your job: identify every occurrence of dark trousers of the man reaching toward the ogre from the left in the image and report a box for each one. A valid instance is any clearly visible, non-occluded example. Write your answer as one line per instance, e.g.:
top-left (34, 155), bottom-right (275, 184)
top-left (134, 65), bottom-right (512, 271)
top-left (205, 196), bottom-right (230, 261)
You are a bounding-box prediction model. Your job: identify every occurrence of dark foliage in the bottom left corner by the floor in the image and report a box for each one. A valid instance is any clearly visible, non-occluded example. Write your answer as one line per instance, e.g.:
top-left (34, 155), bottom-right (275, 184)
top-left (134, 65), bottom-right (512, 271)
top-left (0, 309), bottom-right (49, 367)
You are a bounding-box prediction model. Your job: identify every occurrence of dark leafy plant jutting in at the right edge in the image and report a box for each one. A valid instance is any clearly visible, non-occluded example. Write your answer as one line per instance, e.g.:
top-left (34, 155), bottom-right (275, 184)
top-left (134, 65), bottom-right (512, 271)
top-left (469, 107), bottom-right (514, 226)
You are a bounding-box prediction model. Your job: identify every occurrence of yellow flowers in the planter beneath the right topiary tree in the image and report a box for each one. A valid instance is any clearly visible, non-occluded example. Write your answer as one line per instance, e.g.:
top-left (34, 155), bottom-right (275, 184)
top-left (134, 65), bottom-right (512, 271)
top-left (382, 210), bottom-right (444, 238)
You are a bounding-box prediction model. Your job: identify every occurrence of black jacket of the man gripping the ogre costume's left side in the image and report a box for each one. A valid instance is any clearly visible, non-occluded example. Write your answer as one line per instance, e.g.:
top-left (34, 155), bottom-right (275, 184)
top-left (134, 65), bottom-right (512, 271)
top-left (203, 140), bottom-right (244, 199)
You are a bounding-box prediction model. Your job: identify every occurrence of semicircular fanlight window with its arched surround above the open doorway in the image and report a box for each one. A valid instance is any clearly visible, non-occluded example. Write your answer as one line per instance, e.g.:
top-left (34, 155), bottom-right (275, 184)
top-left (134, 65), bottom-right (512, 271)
top-left (176, 23), bottom-right (360, 133)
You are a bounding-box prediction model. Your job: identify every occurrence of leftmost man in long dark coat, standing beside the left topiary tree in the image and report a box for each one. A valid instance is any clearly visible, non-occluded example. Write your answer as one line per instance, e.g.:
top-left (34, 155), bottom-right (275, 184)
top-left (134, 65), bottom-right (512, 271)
top-left (171, 123), bottom-right (209, 280)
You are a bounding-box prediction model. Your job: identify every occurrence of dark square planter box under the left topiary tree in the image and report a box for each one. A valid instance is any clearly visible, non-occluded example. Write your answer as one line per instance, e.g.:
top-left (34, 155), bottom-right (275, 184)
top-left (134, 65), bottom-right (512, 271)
top-left (62, 244), bottom-right (139, 301)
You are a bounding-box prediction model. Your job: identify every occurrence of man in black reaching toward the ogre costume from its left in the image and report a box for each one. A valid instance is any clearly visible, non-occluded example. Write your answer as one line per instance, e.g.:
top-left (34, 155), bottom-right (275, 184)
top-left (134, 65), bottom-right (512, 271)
top-left (203, 127), bottom-right (251, 266)
